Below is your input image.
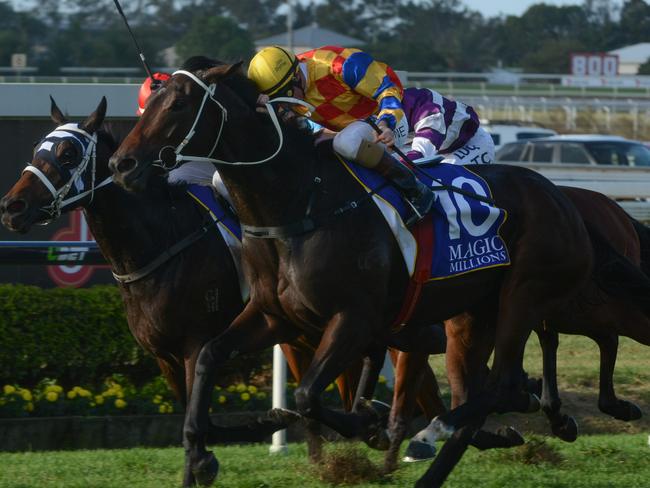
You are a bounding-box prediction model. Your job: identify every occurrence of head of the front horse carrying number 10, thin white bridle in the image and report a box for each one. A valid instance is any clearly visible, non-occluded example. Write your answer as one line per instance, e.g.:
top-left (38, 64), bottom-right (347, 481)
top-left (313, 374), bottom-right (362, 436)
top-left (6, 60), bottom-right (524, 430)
top-left (110, 58), bottom-right (258, 191)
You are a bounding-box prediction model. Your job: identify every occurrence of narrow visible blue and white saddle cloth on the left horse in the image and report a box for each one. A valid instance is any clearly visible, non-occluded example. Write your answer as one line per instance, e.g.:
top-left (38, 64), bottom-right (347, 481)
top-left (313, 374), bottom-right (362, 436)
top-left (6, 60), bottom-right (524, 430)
top-left (187, 184), bottom-right (250, 302)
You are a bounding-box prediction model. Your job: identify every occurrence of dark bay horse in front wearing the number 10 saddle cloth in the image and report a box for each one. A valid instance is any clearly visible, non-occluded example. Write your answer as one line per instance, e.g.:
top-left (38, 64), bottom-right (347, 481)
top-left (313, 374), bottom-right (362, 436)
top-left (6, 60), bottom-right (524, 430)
top-left (105, 65), bottom-right (616, 484)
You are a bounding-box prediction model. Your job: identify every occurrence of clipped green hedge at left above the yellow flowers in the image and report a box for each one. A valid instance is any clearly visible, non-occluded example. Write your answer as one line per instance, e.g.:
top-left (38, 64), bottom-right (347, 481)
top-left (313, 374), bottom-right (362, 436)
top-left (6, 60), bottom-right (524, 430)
top-left (0, 285), bottom-right (159, 386)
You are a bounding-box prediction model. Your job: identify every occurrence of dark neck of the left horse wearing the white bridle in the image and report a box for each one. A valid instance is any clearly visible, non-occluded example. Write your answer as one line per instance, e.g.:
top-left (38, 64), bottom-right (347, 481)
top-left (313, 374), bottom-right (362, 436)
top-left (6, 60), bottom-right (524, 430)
top-left (84, 180), bottom-right (199, 274)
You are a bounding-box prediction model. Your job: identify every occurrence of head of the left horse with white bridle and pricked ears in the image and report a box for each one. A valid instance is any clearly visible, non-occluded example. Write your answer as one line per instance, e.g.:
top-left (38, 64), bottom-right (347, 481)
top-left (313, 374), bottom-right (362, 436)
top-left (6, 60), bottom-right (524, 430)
top-left (0, 97), bottom-right (112, 233)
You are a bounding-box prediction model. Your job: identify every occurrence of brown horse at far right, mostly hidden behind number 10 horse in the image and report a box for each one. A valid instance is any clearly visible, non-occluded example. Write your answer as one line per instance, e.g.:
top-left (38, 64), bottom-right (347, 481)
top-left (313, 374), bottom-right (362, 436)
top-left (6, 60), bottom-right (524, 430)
top-left (416, 187), bottom-right (650, 449)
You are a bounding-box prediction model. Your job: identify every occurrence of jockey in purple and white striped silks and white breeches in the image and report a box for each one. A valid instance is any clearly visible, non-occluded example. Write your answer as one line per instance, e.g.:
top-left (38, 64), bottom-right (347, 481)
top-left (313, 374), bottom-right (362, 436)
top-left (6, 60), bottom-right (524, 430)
top-left (395, 88), bottom-right (495, 165)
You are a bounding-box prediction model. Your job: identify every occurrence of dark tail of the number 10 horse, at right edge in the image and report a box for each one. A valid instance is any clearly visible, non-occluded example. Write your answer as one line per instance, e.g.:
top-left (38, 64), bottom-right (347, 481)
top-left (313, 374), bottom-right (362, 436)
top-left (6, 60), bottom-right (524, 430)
top-left (587, 225), bottom-right (650, 314)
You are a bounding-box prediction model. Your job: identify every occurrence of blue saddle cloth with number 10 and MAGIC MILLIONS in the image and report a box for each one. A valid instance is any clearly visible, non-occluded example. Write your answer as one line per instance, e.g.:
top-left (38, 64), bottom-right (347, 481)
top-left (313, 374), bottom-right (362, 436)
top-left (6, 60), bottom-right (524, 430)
top-left (339, 158), bottom-right (510, 281)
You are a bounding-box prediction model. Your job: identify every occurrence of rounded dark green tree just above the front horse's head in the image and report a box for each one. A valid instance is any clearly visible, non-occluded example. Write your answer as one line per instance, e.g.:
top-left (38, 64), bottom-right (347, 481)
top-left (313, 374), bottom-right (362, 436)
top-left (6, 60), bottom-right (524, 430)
top-left (176, 16), bottom-right (255, 61)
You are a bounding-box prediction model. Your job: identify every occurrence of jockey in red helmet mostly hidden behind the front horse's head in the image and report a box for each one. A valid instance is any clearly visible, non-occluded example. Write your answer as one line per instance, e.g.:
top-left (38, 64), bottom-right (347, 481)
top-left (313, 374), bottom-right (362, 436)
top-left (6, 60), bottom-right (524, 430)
top-left (136, 73), bottom-right (232, 200)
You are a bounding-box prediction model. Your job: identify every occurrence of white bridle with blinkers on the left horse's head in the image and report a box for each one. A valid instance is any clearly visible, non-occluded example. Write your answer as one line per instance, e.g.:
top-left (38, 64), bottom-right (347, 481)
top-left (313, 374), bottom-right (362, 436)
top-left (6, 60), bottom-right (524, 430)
top-left (22, 123), bottom-right (113, 224)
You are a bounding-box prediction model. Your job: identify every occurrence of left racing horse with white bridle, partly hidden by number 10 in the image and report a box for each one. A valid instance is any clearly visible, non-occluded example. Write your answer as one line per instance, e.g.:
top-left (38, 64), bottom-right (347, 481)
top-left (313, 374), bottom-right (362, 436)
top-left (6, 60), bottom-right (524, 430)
top-left (0, 96), bottom-right (444, 472)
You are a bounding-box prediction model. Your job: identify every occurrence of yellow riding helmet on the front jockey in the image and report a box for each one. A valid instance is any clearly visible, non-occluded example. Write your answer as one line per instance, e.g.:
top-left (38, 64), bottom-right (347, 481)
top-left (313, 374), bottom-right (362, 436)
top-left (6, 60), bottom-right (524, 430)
top-left (248, 46), bottom-right (299, 96)
